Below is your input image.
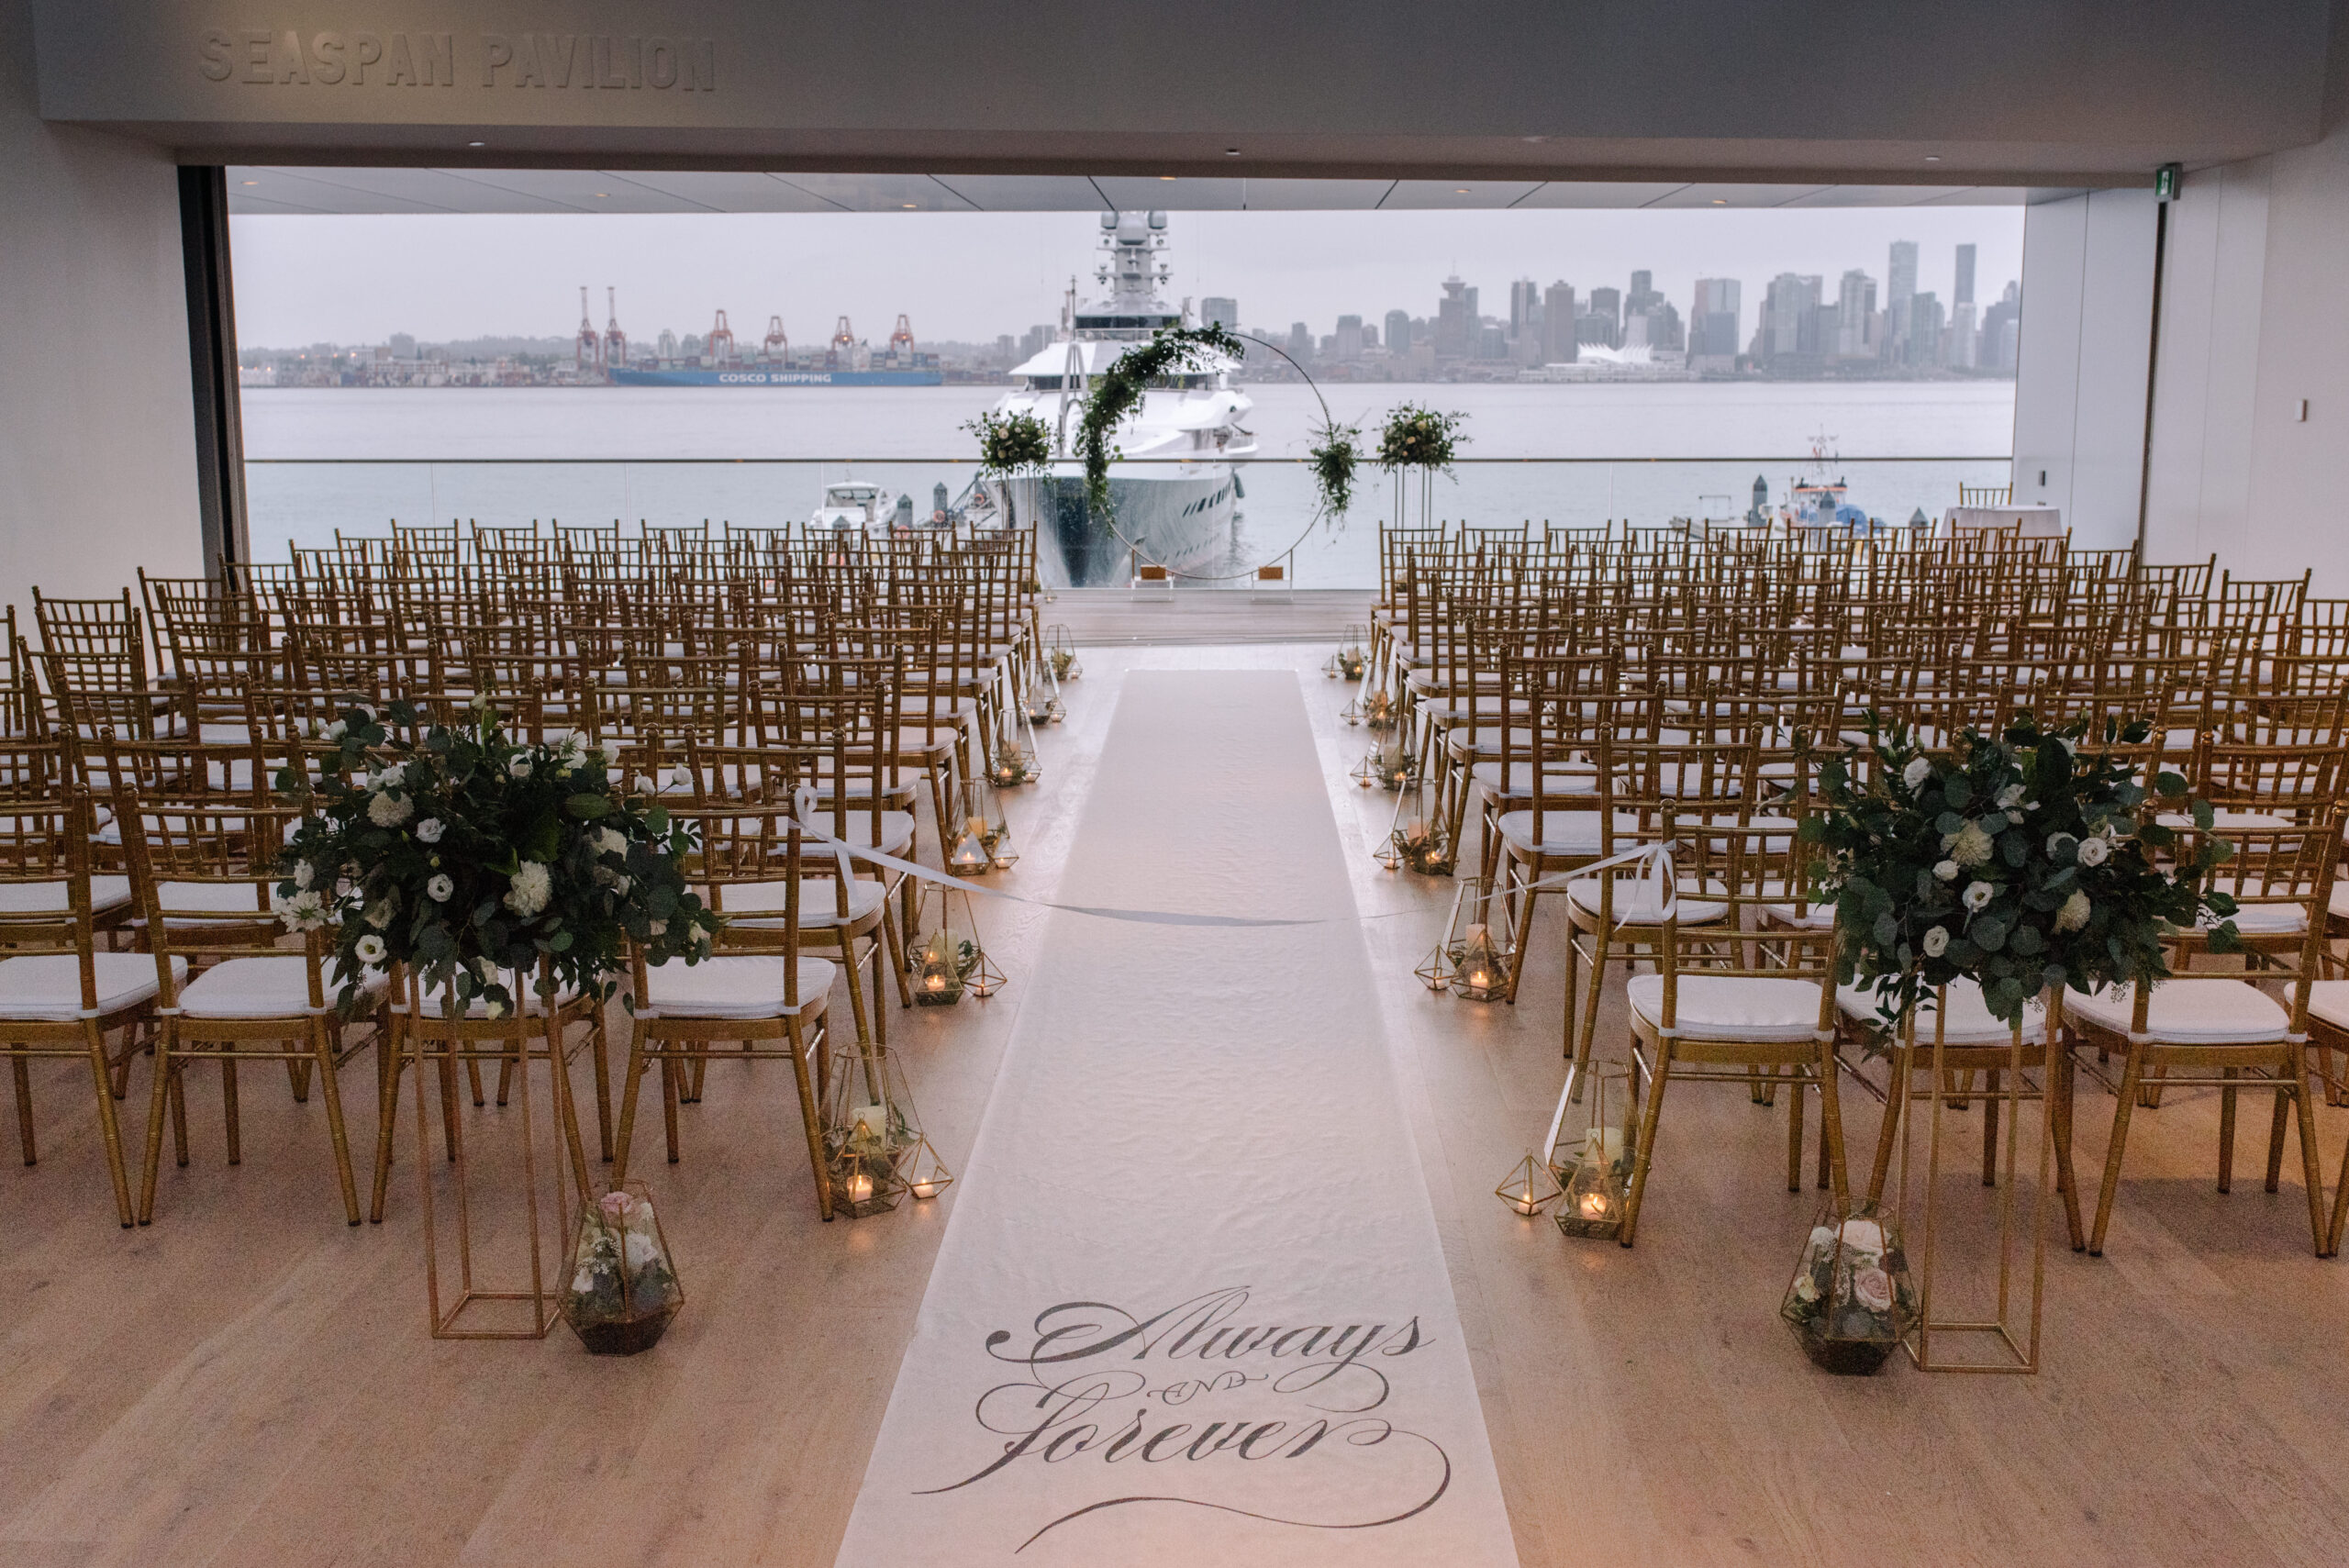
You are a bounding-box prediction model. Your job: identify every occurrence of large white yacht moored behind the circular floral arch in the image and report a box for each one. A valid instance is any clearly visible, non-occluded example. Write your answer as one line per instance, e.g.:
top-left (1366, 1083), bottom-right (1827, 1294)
top-left (968, 211), bottom-right (1257, 587)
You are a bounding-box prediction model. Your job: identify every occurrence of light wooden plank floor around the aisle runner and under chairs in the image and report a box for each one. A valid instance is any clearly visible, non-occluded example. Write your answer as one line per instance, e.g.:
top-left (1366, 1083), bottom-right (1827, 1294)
top-left (14, 643), bottom-right (2349, 1568)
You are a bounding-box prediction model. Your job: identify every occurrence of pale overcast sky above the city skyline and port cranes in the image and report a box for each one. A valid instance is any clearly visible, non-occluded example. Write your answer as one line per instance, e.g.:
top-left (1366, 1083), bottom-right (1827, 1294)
top-left (232, 206), bottom-right (2022, 348)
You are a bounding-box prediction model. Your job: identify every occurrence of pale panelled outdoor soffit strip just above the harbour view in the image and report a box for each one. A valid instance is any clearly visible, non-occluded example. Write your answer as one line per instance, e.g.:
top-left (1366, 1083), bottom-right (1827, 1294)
top-left (228, 167), bottom-right (2055, 214)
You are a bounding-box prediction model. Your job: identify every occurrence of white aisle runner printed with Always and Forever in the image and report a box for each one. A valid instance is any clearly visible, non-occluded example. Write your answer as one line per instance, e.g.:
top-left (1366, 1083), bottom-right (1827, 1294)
top-left (839, 672), bottom-right (1518, 1568)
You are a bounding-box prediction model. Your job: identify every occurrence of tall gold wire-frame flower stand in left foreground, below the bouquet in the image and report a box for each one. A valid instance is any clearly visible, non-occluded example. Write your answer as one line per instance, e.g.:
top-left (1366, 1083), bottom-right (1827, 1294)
top-left (385, 974), bottom-right (596, 1340)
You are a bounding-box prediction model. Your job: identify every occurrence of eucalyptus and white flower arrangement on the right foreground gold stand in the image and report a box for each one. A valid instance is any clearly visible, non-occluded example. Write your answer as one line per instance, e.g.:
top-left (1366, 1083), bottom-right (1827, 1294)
top-left (1802, 714), bottom-right (2236, 1023)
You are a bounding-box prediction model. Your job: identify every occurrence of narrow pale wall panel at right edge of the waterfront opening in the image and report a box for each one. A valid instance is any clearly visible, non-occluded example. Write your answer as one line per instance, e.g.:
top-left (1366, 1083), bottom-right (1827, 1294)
top-left (2013, 190), bottom-right (2154, 550)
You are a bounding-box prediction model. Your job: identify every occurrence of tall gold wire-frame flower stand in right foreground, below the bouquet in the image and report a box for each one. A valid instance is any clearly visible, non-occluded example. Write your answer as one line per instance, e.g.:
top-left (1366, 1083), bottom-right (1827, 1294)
top-left (1870, 991), bottom-right (2065, 1373)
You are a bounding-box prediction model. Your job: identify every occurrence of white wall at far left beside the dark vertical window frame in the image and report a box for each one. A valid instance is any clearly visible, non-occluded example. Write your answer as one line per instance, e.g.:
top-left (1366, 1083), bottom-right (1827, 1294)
top-left (0, 0), bottom-right (202, 619)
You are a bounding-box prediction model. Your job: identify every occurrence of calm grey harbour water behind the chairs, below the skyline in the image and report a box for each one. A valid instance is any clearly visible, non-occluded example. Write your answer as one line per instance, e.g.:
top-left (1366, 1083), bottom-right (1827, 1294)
top-left (244, 383), bottom-right (2015, 587)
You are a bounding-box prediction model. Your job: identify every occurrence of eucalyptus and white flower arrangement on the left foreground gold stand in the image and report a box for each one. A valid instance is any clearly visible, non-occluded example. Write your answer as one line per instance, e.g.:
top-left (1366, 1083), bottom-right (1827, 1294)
top-left (275, 702), bottom-right (718, 1017)
